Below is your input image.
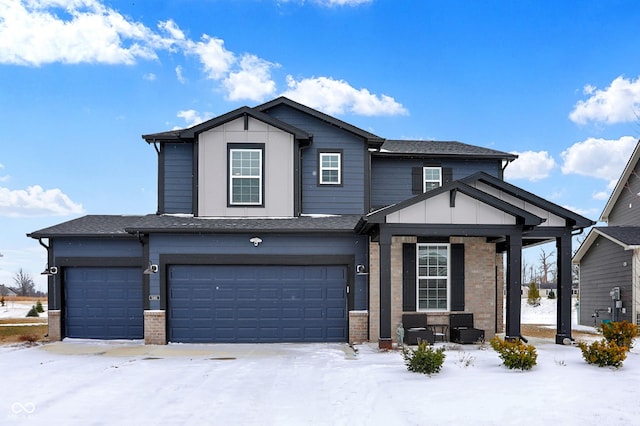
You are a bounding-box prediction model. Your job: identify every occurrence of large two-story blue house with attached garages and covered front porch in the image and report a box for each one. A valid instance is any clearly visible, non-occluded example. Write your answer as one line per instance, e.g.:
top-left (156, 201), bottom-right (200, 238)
top-left (29, 98), bottom-right (592, 347)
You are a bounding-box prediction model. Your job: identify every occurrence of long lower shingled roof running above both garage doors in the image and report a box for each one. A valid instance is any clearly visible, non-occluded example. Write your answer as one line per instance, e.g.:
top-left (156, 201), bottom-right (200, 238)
top-left (27, 215), bottom-right (360, 238)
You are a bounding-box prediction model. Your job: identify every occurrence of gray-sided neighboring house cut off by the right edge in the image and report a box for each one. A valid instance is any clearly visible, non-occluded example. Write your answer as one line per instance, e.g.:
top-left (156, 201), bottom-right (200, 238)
top-left (573, 143), bottom-right (640, 325)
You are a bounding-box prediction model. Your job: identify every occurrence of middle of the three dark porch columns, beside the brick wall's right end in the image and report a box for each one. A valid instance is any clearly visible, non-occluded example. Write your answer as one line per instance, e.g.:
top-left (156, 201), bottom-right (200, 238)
top-left (505, 232), bottom-right (522, 339)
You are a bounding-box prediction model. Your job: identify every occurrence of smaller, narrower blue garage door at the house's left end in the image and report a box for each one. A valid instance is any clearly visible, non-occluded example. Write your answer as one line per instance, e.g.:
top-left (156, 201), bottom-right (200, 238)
top-left (64, 268), bottom-right (144, 339)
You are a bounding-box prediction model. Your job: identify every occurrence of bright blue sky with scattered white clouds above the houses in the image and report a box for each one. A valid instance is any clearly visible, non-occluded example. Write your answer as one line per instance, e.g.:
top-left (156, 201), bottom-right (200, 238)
top-left (0, 0), bottom-right (640, 289)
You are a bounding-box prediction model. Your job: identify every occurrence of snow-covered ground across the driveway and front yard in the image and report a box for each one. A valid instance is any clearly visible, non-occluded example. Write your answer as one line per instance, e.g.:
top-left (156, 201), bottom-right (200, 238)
top-left (0, 303), bottom-right (640, 426)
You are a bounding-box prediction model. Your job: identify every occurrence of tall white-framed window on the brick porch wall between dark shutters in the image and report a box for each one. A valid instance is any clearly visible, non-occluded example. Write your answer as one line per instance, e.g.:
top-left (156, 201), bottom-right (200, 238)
top-left (417, 243), bottom-right (450, 311)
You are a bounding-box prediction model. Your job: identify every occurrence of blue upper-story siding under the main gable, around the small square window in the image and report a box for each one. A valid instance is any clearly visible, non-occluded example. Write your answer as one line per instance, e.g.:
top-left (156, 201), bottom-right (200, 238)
top-left (268, 105), bottom-right (367, 214)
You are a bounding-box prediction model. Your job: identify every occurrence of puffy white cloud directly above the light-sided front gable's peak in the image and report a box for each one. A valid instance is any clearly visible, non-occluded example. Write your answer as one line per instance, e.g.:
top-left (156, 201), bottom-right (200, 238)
top-left (224, 55), bottom-right (276, 101)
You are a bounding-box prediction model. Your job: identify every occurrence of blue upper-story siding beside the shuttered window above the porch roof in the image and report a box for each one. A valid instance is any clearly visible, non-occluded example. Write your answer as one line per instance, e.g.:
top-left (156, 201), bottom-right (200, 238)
top-left (371, 157), bottom-right (501, 209)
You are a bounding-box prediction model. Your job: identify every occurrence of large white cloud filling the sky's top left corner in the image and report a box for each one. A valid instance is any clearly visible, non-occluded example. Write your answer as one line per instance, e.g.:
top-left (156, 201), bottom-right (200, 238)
top-left (0, 0), bottom-right (162, 66)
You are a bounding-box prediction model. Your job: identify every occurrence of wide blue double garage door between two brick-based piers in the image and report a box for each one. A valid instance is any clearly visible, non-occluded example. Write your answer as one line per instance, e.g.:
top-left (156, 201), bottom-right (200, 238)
top-left (168, 265), bottom-right (347, 343)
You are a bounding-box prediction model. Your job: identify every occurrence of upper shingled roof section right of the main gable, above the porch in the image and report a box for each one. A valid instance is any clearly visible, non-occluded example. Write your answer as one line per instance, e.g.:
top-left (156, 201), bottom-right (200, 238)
top-left (374, 140), bottom-right (518, 161)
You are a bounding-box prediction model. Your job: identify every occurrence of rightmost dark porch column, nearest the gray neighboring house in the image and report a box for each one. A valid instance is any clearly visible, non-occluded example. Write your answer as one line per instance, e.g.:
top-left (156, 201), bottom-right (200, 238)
top-left (556, 231), bottom-right (573, 345)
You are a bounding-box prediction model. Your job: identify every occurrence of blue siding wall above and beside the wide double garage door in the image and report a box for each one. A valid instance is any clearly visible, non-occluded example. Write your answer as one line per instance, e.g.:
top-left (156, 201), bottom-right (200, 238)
top-left (149, 234), bottom-right (368, 310)
